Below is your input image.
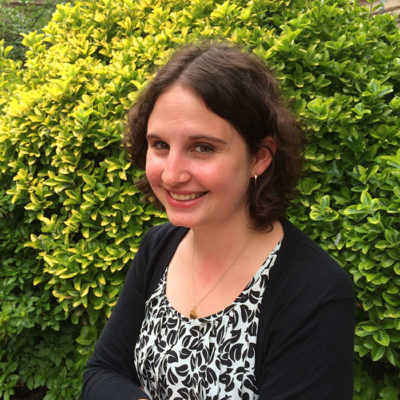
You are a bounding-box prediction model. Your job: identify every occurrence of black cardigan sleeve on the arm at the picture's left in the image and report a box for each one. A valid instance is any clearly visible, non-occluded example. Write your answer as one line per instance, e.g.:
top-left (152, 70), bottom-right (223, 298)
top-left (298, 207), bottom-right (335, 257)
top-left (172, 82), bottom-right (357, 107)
top-left (82, 231), bottom-right (155, 400)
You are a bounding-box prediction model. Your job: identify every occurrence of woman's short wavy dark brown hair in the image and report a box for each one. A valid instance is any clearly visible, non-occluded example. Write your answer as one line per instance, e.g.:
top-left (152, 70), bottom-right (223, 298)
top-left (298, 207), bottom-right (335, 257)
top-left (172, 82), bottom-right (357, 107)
top-left (124, 43), bottom-right (305, 230)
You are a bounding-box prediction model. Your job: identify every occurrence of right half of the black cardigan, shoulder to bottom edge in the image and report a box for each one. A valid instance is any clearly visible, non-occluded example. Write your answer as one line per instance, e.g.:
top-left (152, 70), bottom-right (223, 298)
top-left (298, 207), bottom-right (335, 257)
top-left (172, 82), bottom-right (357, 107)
top-left (256, 222), bottom-right (355, 400)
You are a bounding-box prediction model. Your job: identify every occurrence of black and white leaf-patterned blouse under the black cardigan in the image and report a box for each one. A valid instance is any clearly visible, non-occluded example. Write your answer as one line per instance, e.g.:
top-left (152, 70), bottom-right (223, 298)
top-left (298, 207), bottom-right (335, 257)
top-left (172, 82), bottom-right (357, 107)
top-left (135, 242), bottom-right (281, 400)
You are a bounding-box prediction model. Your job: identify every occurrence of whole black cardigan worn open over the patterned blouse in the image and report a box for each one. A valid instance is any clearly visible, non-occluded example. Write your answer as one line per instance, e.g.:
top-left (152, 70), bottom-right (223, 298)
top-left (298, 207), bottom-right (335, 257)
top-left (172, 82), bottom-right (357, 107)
top-left (83, 220), bottom-right (354, 400)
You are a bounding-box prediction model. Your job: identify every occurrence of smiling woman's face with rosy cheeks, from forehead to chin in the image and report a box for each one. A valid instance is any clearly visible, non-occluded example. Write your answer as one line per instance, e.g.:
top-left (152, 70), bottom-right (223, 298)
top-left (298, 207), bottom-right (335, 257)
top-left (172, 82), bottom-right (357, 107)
top-left (146, 84), bottom-right (255, 228)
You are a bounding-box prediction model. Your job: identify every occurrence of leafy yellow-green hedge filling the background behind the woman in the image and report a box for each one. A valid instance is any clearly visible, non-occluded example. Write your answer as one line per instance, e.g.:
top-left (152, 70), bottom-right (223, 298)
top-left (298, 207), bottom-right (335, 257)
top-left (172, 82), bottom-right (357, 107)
top-left (0, 0), bottom-right (400, 400)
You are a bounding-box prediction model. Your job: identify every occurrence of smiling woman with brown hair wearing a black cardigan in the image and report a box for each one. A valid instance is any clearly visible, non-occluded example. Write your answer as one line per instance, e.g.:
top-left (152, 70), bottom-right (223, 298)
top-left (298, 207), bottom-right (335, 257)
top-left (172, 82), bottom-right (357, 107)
top-left (83, 45), bottom-right (354, 400)
